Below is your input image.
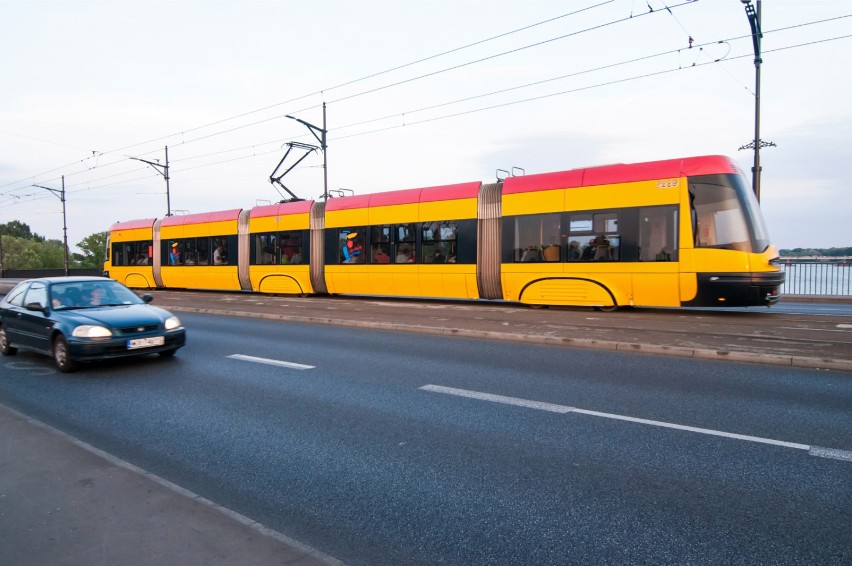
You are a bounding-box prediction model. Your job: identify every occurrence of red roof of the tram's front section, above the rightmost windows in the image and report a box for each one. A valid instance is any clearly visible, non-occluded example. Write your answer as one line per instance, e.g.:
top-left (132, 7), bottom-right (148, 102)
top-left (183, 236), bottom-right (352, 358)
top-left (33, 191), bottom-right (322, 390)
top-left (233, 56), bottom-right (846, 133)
top-left (503, 155), bottom-right (740, 195)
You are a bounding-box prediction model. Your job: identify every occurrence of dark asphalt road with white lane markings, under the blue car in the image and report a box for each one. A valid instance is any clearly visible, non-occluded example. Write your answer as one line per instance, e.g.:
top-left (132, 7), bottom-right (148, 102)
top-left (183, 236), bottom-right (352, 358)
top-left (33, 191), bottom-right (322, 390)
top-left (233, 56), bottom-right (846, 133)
top-left (0, 312), bottom-right (852, 564)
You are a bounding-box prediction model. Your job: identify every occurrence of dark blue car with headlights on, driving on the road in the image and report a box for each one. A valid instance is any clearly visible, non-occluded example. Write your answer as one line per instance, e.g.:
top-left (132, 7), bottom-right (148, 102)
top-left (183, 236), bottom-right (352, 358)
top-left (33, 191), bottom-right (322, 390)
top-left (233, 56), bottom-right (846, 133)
top-left (0, 277), bottom-right (186, 372)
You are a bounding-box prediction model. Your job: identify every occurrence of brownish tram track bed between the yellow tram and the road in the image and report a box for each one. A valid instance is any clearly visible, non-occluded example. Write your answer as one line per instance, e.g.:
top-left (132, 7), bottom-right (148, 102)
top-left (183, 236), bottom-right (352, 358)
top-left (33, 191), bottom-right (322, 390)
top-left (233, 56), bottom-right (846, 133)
top-left (151, 291), bottom-right (852, 371)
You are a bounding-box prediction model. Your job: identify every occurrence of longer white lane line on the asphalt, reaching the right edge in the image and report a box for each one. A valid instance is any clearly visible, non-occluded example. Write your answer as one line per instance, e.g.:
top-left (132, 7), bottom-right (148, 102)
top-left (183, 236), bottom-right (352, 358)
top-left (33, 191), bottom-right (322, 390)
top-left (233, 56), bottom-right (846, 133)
top-left (420, 385), bottom-right (852, 462)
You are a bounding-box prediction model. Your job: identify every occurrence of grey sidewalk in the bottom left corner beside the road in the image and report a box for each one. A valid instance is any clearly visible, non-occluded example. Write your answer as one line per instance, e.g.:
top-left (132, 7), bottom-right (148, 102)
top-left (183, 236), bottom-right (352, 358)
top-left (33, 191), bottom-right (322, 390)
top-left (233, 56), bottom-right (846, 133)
top-left (0, 405), bottom-right (340, 566)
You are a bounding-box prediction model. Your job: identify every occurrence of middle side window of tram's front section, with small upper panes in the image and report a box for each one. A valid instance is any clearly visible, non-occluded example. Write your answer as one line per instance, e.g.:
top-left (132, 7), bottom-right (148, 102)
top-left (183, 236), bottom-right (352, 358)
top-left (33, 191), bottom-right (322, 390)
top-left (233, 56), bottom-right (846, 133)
top-left (567, 212), bottom-right (621, 261)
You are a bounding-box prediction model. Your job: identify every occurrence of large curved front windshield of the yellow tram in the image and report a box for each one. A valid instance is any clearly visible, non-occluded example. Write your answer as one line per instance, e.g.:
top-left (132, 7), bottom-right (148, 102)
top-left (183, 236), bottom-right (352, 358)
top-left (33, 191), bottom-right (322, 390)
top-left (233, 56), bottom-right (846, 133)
top-left (689, 175), bottom-right (769, 253)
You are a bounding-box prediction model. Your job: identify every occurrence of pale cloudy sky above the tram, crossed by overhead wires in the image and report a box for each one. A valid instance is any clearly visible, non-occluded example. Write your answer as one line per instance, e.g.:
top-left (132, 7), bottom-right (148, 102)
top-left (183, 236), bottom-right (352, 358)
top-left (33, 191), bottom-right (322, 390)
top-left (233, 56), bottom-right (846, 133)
top-left (0, 0), bottom-right (852, 251)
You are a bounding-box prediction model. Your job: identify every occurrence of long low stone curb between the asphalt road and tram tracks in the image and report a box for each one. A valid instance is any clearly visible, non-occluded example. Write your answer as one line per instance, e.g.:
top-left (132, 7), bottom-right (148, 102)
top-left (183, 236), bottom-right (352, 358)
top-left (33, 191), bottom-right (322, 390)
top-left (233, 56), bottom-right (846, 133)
top-left (169, 306), bottom-right (852, 372)
